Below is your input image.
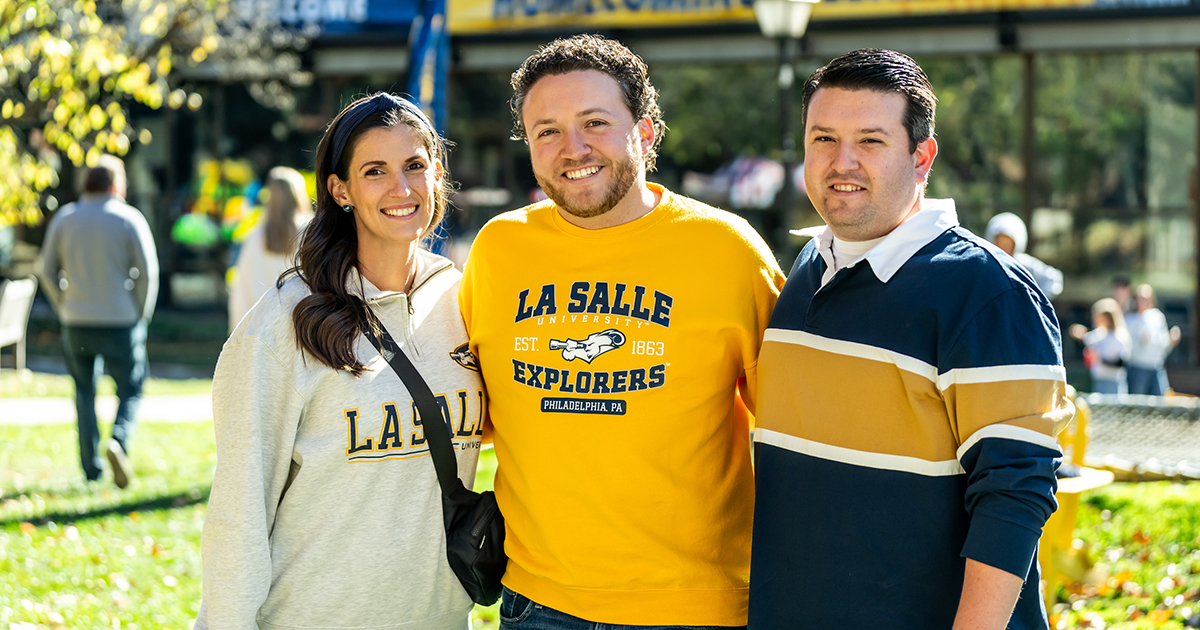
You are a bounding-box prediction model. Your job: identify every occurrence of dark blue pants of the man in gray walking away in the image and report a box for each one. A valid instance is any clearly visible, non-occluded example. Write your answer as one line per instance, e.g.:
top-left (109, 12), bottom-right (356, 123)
top-left (62, 322), bottom-right (149, 481)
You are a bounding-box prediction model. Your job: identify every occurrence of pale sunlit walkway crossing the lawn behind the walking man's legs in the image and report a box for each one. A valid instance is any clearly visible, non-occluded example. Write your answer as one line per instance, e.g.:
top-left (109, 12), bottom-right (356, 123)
top-left (0, 394), bottom-right (212, 425)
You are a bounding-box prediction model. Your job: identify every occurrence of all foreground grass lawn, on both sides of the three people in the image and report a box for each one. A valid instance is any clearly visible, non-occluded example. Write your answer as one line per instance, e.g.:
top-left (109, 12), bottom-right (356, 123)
top-left (0, 412), bottom-right (1200, 630)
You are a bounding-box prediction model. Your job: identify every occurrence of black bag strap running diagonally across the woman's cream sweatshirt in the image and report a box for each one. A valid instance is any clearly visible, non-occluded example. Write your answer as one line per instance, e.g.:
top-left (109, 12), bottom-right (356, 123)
top-left (362, 304), bottom-right (464, 493)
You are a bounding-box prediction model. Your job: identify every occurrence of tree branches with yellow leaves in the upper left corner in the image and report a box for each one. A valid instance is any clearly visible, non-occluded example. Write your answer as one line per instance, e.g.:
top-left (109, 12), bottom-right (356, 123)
top-left (0, 0), bottom-right (312, 226)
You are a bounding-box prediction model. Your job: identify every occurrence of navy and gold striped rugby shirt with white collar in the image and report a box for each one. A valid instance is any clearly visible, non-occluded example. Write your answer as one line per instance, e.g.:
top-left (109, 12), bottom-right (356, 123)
top-left (750, 199), bottom-right (1074, 630)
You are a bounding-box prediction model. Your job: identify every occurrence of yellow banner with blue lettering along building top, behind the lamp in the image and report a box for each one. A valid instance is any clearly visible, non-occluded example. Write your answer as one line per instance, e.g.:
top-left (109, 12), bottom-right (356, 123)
top-left (449, 0), bottom-right (1112, 35)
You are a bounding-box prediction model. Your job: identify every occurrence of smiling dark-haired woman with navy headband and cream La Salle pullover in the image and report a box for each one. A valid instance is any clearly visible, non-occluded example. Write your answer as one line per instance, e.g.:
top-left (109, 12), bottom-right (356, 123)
top-left (196, 94), bottom-right (485, 630)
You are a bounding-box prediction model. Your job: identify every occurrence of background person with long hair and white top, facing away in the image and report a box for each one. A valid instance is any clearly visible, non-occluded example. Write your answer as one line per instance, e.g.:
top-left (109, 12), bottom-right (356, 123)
top-left (229, 167), bottom-right (312, 331)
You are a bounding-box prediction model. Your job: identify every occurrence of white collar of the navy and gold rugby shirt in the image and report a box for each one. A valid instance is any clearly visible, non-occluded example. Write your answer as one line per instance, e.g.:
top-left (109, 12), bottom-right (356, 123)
top-left (792, 198), bottom-right (959, 287)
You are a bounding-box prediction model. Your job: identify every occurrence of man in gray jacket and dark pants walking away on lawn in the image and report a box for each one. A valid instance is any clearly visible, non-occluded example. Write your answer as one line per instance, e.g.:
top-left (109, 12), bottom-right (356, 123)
top-left (40, 155), bottom-right (158, 488)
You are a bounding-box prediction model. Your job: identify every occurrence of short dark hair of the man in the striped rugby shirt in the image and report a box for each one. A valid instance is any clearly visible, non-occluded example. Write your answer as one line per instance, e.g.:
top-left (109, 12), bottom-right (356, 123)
top-left (800, 48), bottom-right (937, 152)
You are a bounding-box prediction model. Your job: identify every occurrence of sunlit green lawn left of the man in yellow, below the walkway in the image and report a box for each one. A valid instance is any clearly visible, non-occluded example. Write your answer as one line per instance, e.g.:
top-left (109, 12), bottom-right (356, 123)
top-left (0, 422), bottom-right (498, 630)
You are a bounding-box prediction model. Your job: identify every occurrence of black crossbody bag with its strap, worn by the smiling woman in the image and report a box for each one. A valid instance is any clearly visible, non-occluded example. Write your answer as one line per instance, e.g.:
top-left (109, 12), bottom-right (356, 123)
top-left (364, 304), bottom-right (509, 606)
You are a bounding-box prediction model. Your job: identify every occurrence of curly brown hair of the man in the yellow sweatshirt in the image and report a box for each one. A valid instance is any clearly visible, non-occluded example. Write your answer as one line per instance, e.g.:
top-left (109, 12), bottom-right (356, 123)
top-left (509, 35), bottom-right (667, 170)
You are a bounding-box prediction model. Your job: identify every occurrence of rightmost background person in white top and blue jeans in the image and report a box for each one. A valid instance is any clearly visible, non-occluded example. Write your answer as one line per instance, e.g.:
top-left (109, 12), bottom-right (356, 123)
top-left (1126, 284), bottom-right (1180, 396)
